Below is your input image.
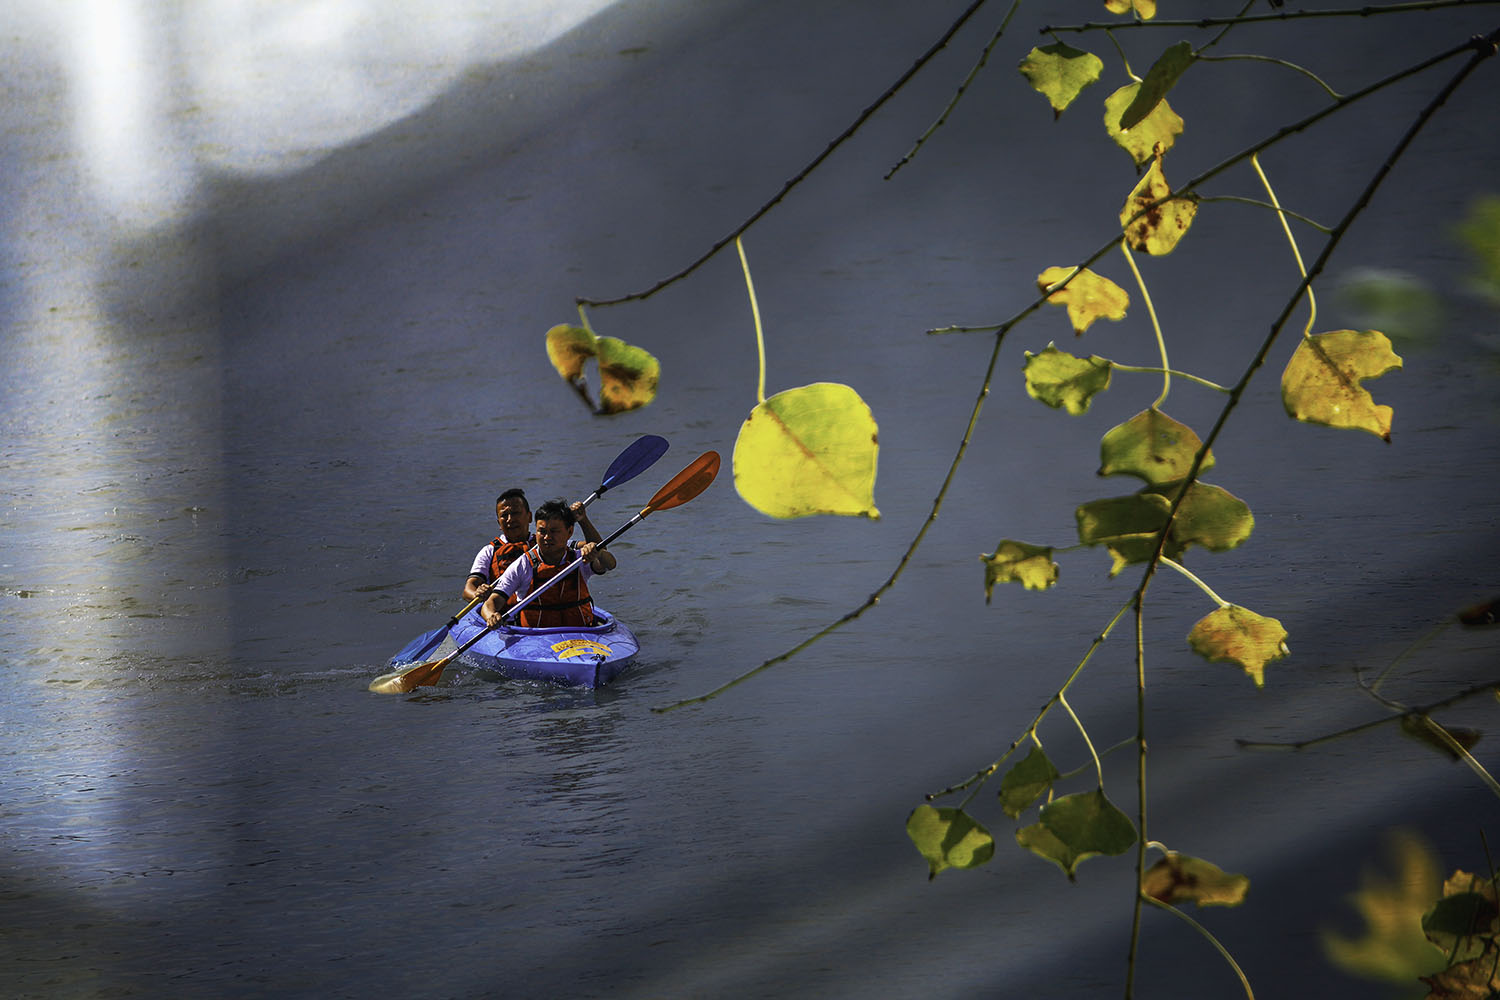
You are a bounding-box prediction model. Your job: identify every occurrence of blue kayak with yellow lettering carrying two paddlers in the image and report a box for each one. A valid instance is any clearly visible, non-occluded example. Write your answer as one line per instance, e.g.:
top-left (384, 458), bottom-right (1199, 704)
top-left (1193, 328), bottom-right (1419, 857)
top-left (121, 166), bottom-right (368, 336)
top-left (438, 606), bottom-right (641, 688)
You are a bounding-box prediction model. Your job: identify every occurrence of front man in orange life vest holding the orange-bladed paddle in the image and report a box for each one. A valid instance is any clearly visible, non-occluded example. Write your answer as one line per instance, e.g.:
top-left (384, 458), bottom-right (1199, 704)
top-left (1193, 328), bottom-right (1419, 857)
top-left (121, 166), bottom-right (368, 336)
top-left (480, 499), bottom-right (615, 628)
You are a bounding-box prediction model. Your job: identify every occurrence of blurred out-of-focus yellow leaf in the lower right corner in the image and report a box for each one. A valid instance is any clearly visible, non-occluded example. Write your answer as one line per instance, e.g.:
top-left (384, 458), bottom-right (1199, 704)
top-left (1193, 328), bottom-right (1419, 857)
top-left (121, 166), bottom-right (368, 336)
top-left (1322, 832), bottom-right (1445, 985)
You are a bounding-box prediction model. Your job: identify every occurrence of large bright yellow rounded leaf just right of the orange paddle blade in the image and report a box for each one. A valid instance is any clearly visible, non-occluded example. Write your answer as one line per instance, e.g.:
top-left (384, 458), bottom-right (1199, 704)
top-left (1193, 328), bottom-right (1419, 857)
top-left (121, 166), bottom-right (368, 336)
top-left (734, 382), bottom-right (881, 517)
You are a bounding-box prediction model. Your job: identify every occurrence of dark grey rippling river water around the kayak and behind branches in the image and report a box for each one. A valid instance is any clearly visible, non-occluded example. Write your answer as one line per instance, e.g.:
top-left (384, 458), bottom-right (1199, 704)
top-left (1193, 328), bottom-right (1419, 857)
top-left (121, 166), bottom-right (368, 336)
top-left (0, 0), bottom-right (1500, 997)
